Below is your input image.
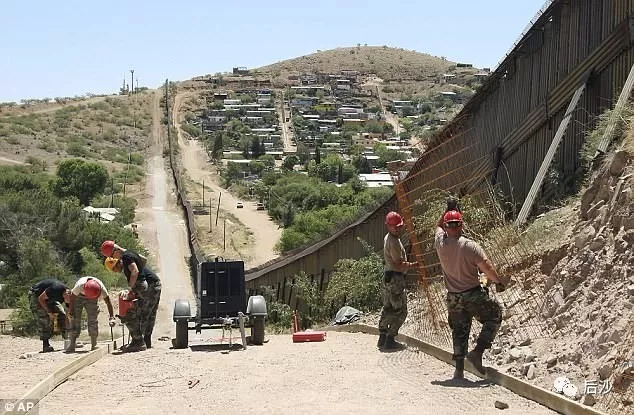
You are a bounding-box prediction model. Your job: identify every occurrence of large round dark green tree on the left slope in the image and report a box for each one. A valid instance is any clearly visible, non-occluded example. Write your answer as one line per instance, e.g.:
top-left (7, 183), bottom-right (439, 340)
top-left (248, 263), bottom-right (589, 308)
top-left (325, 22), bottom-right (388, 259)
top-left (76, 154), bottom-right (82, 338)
top-left (53, 159), bottom-right (110, 206)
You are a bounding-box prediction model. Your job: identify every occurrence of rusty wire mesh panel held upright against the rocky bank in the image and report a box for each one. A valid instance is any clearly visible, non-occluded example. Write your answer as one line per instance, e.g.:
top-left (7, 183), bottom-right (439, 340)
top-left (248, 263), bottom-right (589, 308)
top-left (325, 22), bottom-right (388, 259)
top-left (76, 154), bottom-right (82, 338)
top-left (389, 136), bottom-right (554, 351)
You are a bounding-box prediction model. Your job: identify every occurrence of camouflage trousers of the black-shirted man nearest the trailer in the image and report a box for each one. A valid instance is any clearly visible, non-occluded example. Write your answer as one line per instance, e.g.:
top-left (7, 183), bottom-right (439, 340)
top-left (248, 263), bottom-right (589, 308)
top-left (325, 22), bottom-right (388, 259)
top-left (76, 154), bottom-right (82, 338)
top-left (121, 282), bottom-right (161, 340)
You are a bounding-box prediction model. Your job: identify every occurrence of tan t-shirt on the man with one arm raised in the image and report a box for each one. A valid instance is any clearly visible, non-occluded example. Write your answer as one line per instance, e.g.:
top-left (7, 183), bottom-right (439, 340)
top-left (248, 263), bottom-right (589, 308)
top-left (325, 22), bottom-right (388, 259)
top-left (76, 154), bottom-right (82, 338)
top-left (434, 228), bottom-right (487, 293)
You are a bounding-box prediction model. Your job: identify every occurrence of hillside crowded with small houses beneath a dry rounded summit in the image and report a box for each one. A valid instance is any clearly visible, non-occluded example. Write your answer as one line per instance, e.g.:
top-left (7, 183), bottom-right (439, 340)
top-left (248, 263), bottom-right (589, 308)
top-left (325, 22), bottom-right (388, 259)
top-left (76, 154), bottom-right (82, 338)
top-left (179, 45), bottom-right (488, 186)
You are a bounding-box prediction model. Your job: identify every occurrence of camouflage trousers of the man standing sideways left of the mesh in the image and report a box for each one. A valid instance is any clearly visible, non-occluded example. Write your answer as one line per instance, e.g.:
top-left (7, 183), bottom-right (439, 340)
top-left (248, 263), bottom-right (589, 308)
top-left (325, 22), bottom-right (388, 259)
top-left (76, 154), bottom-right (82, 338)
top-left (379, 271), bottom-right (407, 336)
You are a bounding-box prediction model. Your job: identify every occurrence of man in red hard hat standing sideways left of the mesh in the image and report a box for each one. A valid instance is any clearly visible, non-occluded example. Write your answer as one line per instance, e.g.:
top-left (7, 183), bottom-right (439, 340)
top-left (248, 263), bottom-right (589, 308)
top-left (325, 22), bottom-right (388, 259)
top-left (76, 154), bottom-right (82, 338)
top-left (377, 212), bottom-right (418, 350)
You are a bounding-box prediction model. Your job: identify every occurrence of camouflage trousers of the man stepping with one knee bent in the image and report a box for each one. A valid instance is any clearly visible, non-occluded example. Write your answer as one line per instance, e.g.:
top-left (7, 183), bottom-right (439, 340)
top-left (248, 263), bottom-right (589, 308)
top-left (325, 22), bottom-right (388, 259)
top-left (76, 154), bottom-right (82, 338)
top-left (447, 286), bottom-right (502, 360)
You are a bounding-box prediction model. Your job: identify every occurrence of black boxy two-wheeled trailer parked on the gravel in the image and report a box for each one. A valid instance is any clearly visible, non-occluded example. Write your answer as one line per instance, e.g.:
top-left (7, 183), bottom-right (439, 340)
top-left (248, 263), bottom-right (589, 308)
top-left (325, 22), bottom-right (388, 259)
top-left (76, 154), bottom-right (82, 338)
top-left (173, 258), bottom-right (267, 349)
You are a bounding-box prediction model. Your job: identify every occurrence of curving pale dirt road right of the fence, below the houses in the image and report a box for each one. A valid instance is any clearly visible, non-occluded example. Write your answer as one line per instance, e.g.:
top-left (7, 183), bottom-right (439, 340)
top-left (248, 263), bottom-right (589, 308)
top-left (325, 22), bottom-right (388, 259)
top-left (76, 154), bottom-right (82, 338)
top-left (173, 93), bottom-right (282, 268)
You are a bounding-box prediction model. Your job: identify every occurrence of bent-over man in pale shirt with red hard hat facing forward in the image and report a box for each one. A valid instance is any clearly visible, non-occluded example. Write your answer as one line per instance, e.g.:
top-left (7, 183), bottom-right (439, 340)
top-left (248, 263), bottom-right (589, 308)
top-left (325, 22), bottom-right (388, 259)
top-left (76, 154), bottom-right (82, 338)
top-left (66, 277), bottom-right (115, 353)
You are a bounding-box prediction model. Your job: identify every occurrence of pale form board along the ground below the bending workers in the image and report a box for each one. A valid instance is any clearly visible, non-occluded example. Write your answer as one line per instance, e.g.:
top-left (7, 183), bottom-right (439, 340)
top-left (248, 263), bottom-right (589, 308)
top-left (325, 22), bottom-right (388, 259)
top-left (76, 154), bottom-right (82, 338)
top-left (0, 337), bottom-right (123, 415)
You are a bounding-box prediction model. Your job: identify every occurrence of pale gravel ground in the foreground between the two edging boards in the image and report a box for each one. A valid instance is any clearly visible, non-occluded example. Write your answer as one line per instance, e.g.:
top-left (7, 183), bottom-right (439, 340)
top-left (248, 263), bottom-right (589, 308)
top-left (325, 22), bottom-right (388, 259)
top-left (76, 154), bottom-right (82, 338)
top-left (34, 332), bottom-right (555, 415)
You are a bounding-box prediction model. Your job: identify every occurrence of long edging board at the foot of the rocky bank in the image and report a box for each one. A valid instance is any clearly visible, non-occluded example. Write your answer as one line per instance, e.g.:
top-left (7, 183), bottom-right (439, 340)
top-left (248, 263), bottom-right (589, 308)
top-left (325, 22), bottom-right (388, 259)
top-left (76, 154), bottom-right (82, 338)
top-left (323, 324), bottom-right (608, 415)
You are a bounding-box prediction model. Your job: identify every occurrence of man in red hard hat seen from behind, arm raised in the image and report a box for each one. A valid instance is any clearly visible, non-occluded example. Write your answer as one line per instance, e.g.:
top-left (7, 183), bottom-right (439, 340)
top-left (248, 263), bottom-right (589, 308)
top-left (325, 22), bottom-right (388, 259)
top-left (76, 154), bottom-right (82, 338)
top-left (434, 198), bottom-right (508, 379)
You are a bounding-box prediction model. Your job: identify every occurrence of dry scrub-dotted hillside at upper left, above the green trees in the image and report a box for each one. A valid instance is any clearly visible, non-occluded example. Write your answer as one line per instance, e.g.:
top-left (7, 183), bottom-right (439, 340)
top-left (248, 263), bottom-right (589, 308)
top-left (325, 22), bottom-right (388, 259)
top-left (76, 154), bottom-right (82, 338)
top-left (0, 93), bottom-right (152, 169)
